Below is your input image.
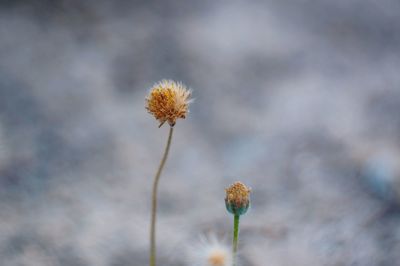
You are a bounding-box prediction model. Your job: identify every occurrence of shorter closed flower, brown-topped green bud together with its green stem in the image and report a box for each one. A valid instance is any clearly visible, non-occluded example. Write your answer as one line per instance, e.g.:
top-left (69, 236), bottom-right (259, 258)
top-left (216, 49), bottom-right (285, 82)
top-left (225, 182), bottom-right (251, 265)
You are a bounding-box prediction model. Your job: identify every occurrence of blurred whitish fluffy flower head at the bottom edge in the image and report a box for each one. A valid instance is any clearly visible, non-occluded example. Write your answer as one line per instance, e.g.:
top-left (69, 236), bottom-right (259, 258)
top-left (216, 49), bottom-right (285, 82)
top-left (188, 235), bottom-right (233, 266)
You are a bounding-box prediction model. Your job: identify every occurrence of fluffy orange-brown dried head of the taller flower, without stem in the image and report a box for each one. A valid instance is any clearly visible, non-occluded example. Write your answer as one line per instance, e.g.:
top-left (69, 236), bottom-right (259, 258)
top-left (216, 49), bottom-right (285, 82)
top-left (146, 80), bottom-right (192, 127)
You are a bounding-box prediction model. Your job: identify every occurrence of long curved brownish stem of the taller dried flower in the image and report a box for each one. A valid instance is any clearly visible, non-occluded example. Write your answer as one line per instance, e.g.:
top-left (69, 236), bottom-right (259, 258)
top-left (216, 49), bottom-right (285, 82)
top-left (149, 127), bottom-right (174, 266)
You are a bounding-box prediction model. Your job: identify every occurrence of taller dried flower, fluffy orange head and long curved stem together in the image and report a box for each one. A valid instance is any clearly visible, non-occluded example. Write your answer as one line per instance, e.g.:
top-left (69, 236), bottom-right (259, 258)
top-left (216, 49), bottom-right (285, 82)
top-left (146, 80), bottom-right (191, 266)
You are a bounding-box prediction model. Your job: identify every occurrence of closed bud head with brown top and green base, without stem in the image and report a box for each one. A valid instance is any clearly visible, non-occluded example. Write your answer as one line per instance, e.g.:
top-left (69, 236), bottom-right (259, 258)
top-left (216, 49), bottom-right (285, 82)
top-left (225, 181), bottom-right (251, 215)
